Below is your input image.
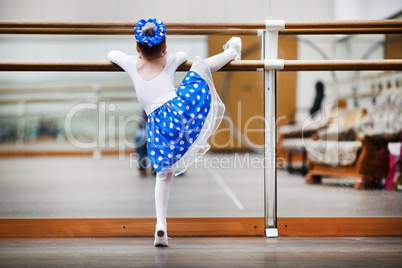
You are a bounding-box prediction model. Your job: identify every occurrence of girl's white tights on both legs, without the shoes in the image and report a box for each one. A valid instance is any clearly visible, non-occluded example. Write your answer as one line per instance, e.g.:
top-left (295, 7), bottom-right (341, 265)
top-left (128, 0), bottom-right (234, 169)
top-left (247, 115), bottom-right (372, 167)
top-left (155, 48), bottom-right (237, 227)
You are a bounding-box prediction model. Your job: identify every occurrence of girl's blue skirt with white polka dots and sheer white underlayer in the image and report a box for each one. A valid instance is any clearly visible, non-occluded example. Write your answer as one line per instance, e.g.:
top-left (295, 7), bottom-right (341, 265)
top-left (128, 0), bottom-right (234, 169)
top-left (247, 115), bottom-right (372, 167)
top-left (147, 62), bottom-right (224, 175)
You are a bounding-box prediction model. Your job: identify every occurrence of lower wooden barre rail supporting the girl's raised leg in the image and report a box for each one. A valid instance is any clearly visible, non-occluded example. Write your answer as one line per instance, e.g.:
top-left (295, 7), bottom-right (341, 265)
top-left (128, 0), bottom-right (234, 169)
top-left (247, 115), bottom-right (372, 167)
top-left (0, 60), bottom-right (402, 72)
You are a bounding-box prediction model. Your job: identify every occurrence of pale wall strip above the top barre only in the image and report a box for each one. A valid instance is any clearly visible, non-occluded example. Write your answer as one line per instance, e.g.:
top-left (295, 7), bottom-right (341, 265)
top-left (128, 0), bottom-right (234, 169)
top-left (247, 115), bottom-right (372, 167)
top-left (0, 0), bottom-right (333, 21)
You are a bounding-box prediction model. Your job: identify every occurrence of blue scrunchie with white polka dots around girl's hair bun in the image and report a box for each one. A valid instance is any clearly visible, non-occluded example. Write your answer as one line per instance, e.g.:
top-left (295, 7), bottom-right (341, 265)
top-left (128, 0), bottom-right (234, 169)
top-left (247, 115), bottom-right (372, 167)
top-left (134, 19), bottom-right (166, 47)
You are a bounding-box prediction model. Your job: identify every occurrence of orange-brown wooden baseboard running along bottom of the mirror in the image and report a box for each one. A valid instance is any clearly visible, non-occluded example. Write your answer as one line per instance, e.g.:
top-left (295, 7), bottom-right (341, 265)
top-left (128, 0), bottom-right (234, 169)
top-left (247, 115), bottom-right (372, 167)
top-left (0, 217), bottom-right (402, 238)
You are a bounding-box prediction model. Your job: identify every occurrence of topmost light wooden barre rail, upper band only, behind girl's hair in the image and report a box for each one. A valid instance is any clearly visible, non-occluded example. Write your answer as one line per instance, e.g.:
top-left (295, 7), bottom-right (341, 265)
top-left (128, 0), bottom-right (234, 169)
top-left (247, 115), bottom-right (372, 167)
top-left (0, 20), bottom-right (402, 29)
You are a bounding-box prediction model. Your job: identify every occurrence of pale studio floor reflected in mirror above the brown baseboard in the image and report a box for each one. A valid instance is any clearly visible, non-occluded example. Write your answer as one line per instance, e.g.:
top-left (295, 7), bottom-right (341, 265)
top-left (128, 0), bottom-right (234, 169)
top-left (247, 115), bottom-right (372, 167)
top-left (0, 153), bottom-right (402, 218)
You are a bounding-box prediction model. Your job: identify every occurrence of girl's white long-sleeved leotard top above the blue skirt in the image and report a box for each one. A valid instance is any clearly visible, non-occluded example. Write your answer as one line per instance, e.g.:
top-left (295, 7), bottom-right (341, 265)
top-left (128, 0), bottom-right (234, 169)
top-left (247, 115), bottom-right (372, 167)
top-left (108, 50), bottom-right (187, 114)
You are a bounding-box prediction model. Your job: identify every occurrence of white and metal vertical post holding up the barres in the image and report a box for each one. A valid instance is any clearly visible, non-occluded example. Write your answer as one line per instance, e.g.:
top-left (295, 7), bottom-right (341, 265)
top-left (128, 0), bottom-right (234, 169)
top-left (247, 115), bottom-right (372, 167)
top-left (262, 20), bottom-right (285, 238)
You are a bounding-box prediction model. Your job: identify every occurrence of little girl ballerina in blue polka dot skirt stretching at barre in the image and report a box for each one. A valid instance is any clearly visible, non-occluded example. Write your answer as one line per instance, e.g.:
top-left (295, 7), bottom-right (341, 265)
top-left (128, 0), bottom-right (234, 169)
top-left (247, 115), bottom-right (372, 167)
top-left (108, 19), bottom-right (242, 246)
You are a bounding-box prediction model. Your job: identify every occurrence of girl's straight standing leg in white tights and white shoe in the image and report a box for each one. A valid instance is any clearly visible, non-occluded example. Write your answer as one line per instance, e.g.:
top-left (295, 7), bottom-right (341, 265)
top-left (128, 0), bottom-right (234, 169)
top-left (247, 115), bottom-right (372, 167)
top-left (154, 171), bottom-right (173, 246)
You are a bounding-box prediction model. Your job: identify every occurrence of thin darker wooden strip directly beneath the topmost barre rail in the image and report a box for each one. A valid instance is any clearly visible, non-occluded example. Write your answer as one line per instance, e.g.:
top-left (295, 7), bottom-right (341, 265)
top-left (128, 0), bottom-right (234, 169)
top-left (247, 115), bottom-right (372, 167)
top-left (0, 27), bottom-right (402, 36)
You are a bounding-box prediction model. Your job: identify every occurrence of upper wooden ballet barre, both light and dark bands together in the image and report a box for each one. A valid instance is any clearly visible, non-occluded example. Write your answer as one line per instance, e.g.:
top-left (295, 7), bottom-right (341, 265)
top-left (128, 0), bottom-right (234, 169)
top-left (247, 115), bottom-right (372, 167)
top-left (0, 20), bottom-right (402, 35)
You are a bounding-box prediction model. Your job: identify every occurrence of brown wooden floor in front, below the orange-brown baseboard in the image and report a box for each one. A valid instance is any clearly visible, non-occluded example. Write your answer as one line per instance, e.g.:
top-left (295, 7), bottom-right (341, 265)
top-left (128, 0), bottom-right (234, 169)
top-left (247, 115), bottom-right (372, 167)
top-left (0, 237), bottom-right (402, 267)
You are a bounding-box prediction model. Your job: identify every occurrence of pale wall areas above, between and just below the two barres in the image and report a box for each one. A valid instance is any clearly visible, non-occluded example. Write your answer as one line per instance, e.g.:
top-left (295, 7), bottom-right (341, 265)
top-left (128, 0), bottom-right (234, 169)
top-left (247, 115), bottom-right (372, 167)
top-left (0, 0), bottom-right (332, 89)
